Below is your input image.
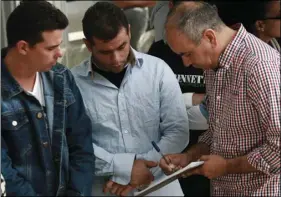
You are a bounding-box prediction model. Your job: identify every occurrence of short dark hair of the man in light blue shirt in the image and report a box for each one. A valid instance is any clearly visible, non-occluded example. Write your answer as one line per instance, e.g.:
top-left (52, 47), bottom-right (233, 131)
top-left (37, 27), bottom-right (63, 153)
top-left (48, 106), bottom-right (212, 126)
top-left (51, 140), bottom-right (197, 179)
top-left (82, 2), bottom-right (129, 44)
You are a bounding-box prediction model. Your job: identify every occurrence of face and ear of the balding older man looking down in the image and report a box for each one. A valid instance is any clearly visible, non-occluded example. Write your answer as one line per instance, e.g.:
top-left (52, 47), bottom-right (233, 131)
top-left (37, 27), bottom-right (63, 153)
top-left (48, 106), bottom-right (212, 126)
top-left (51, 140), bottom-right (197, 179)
top-left (166, 27), bottom-right (217, 69)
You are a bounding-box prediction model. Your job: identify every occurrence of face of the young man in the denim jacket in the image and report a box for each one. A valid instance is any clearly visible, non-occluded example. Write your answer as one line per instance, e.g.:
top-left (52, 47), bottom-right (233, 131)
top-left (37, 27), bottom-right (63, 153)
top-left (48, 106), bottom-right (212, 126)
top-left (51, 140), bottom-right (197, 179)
top-left (23, 30), bottom-right (63, 72)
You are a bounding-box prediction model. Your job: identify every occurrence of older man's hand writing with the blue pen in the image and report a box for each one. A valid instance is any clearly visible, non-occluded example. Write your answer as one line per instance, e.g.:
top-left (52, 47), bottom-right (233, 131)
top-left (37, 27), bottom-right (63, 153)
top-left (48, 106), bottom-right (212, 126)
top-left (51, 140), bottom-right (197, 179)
top-left (159, 153), bottom-right (191, 175)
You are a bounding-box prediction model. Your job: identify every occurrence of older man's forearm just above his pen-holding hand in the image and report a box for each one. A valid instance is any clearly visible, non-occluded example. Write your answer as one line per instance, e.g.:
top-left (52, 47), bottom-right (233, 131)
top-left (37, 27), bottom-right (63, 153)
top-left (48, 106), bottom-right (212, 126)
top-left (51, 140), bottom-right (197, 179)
top-left (186, 142), bottom-right (210, 161)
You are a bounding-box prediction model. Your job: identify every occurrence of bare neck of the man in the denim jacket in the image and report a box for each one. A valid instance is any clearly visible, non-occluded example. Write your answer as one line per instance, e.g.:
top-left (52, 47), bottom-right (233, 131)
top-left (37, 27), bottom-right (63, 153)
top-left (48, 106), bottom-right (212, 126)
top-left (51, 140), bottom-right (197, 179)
top-left (4, 49), bottom-right (36, 91)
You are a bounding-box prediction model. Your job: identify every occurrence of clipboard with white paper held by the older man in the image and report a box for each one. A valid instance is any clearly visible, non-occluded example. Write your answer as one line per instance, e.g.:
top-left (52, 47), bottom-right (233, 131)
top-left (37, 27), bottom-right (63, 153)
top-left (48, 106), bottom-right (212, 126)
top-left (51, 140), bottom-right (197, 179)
top-left (134, 161), bottom-right (204, 196)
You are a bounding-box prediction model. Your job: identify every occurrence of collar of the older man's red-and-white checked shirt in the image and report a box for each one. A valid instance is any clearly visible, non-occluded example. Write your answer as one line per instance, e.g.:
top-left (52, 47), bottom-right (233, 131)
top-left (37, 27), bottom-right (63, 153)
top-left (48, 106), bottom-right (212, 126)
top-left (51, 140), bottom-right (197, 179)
top-left (218, 23), bottom-right (247, 68)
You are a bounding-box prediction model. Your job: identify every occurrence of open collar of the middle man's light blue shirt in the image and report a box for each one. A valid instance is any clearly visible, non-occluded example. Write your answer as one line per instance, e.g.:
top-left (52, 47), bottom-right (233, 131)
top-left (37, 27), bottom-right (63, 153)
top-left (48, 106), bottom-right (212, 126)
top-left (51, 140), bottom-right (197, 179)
top-left (84, 47), bottom-right (143, 76)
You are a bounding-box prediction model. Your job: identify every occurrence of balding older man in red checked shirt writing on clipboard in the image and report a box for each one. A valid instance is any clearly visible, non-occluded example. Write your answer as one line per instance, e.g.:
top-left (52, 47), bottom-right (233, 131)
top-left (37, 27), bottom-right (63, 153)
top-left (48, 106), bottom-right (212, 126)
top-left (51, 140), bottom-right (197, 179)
top-left (160, 2), bottom-right (280, 196)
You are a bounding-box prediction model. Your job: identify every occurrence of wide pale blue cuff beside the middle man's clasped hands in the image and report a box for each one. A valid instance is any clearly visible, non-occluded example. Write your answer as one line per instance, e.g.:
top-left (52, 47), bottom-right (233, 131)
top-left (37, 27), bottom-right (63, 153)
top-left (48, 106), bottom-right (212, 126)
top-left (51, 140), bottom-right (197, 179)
top-left (111, 153), bottom-right (136, 185)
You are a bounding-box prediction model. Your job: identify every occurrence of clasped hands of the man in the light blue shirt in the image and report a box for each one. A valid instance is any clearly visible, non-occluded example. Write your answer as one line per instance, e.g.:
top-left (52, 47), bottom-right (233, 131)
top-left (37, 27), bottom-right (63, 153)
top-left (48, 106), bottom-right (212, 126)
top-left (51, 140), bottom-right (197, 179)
top-left (103, 159), bottom-right (158, 196)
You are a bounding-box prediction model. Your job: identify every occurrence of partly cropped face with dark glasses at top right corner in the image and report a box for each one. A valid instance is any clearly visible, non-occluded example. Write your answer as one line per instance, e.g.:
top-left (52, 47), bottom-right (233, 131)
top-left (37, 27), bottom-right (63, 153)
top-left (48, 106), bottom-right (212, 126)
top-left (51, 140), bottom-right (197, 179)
top-left (256, 1), bottom-right (280, 38)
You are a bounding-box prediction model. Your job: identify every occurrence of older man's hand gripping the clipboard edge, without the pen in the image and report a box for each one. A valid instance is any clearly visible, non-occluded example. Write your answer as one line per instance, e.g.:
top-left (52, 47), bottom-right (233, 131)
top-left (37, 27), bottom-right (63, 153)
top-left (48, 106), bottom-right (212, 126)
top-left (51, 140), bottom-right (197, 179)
top-left (182, 155), bottom-right (227, 179)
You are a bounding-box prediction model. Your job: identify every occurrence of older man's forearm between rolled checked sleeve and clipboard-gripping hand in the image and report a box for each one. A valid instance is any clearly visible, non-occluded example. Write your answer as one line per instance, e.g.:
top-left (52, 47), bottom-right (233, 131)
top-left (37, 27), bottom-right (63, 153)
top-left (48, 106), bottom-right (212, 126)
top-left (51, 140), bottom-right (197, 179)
top-left (226, 156), bottom-right (258, 174)
